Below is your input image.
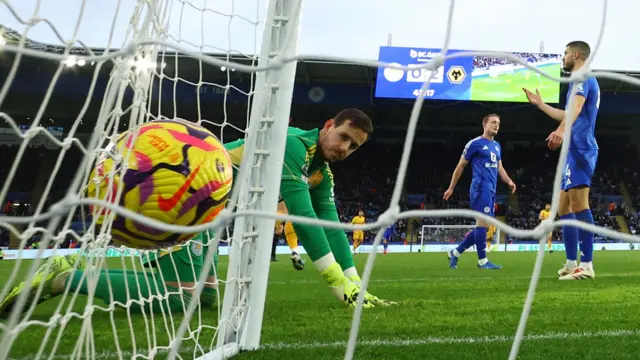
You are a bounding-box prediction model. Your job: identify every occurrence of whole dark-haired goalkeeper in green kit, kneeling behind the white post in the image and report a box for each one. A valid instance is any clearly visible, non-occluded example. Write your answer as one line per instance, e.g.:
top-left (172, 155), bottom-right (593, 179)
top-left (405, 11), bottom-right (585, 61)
top-left (0, 109), bottom-right (390, 314)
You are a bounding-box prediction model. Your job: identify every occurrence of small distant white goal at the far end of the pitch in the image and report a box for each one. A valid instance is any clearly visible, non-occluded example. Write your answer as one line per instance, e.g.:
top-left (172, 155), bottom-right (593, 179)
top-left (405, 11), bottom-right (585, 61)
top-left (420, 225), bottom-right (500, 252)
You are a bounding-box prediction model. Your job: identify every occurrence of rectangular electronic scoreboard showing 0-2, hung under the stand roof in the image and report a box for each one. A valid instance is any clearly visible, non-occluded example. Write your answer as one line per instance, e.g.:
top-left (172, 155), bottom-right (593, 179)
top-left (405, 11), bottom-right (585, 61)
top-left (375, 46), bottom-right (562, 103)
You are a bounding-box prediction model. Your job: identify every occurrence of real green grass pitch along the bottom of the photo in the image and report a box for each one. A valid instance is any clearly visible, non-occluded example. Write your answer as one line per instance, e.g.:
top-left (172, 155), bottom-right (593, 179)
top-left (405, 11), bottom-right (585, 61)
top-left (0, 251), bottom-right (640, 360)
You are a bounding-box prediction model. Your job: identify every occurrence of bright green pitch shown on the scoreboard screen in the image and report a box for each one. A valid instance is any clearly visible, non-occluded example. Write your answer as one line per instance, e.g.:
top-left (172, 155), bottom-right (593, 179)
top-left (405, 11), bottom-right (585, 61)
top-left (471, 64), bottom-right (560, 103)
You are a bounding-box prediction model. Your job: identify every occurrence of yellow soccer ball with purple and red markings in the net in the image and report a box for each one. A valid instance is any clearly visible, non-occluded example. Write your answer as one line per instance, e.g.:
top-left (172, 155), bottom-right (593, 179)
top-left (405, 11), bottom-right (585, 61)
top-left (87, 120), bottom-right (233, 249)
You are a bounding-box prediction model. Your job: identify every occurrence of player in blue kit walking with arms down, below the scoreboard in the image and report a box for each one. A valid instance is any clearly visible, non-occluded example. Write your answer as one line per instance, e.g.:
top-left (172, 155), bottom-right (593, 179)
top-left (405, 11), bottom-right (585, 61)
top-left (443, 114), bottom-right (516, 270)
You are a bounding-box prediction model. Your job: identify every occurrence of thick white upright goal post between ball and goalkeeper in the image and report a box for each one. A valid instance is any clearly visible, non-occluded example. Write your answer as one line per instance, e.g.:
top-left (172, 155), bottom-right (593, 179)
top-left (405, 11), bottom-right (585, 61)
top-left (211, 0), bottom-right (302, 360)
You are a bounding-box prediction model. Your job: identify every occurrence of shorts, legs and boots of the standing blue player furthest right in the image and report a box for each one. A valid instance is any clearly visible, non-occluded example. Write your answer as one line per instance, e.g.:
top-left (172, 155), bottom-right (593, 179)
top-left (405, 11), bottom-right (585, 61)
top-left (560, 150), bottom-right (598, 280)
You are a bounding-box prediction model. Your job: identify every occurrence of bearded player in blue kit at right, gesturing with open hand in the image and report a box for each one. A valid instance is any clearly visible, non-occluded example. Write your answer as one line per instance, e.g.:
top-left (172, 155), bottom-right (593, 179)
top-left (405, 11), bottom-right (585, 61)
top-left (524, 41), bottom-right (600, 280)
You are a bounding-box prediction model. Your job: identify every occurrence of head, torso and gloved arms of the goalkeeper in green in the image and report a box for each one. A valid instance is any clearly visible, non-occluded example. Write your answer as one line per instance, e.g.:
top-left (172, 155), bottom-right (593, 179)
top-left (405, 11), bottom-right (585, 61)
top-left (225, 109), bottom-right (391, 307)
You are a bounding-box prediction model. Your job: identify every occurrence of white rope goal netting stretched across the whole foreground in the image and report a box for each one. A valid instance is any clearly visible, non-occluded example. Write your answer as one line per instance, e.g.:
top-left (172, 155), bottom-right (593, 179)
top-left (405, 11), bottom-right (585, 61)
top-left (0, 0), bottom-right (640, 360)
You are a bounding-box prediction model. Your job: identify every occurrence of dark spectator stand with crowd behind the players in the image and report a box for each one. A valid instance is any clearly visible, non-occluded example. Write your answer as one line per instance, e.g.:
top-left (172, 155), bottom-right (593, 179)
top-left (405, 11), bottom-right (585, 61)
top-left (0, 141), bottom-right (640, 250)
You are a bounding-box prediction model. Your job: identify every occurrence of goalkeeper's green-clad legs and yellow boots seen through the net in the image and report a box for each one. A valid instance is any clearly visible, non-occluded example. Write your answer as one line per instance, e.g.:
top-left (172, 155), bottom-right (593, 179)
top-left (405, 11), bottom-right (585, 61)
top-left (0, 231), bottom-right (218, 317)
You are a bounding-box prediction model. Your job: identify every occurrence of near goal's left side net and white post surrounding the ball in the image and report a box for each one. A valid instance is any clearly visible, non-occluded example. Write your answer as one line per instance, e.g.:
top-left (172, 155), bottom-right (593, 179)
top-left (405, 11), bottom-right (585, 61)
top-left (0, 0), bottom-right (300, 359)
